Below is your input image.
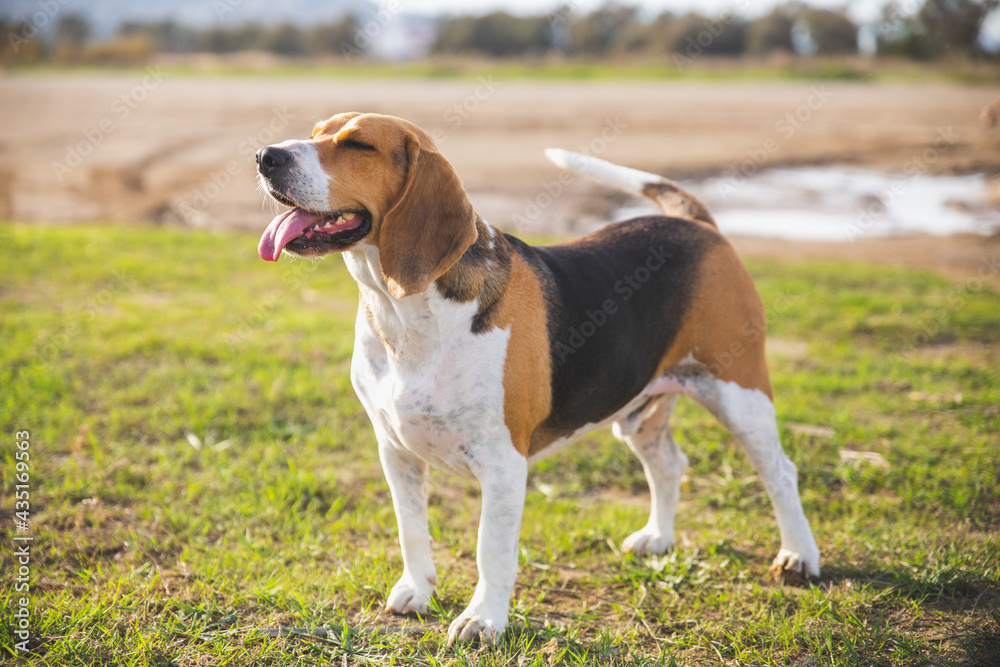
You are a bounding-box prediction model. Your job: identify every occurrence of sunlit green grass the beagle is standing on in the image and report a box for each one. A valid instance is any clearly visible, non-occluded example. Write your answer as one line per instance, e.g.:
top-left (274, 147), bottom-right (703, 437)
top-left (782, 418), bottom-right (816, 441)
top-left (0, 224), bottom-right (1000, 666)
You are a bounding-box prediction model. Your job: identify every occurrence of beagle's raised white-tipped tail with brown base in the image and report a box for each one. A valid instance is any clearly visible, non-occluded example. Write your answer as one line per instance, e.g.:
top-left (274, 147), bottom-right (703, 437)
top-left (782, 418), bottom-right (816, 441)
top-left (545, 148), bottom-right (716, 227)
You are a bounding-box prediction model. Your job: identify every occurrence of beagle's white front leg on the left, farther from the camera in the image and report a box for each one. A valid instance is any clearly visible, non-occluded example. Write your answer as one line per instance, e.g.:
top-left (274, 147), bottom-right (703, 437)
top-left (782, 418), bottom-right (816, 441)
top-left (378, 438), bottom-right (437, 614)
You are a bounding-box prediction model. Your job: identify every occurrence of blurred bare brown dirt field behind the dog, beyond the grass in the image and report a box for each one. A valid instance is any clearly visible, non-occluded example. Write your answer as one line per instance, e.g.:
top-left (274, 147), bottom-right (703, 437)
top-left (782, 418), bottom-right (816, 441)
top-left (0, 68), bottom-right (1000, 283)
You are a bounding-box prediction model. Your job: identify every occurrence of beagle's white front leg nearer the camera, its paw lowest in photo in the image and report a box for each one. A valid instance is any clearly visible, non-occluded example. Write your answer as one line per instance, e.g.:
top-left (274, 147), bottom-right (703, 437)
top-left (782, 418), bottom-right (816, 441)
top-left (448, 445), bottom-right (528, 646)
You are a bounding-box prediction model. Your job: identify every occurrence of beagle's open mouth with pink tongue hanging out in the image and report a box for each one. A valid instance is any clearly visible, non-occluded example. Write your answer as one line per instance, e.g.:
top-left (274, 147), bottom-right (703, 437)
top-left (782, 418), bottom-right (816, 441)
top-left (257, 206), bottom-right (372, 262)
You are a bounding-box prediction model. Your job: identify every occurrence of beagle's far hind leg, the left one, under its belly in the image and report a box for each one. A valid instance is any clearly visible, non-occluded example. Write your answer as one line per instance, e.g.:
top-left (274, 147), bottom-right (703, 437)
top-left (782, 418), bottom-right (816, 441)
top-left (612, 394), bottom-right (687, 554)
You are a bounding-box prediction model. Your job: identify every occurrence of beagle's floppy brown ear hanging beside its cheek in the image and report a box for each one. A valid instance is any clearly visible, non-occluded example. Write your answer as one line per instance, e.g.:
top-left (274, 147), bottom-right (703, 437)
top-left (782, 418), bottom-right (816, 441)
top-left (378, 133), bottom-right (476, 299)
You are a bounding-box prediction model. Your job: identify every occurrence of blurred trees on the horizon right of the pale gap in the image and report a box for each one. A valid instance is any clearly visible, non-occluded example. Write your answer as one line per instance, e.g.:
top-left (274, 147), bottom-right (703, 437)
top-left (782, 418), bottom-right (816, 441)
top-left (431, 0), bottom-right (998, 58)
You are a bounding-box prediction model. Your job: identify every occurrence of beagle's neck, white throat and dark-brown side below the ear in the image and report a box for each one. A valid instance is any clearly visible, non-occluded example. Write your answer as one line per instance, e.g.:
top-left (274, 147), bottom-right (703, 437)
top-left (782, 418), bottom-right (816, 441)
top-left (344, 217), bottom-right (513, 359)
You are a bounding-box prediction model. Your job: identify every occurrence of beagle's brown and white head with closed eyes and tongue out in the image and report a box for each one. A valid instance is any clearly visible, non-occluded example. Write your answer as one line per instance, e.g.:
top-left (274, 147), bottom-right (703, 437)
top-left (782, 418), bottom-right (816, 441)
top-left (257, 112), bottom-right (476, 297)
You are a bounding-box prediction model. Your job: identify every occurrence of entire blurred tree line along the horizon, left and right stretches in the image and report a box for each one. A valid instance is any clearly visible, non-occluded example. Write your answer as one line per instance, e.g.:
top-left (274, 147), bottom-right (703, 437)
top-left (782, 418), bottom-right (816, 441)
top-left (0, 0), bottom-right (1000, 62)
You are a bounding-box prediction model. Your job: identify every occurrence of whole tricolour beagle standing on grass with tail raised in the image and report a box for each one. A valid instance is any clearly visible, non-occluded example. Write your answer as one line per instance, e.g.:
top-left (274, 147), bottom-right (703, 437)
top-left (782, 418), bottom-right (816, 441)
top-left (257, 113), bottom-right (819, 645)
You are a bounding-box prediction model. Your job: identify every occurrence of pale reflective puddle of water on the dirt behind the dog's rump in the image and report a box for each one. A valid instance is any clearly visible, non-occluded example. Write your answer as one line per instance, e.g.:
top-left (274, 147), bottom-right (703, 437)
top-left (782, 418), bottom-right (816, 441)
top-left (619, 166), bottom-right (1000, 241)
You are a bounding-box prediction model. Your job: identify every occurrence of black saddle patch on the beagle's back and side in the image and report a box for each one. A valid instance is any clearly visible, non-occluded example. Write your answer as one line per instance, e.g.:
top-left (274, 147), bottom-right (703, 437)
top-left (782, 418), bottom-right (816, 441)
top-left (508, 216), bottom-right (722, 436)
